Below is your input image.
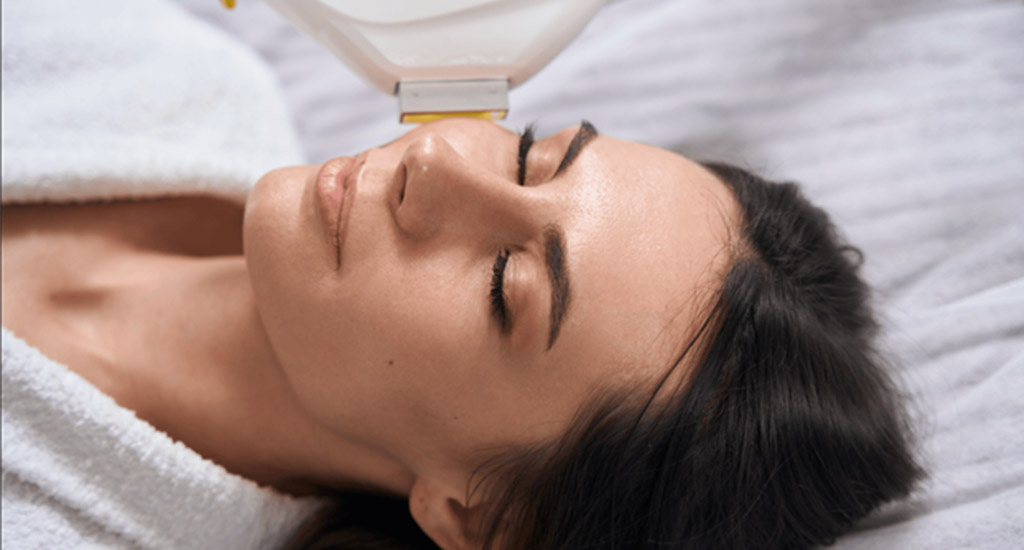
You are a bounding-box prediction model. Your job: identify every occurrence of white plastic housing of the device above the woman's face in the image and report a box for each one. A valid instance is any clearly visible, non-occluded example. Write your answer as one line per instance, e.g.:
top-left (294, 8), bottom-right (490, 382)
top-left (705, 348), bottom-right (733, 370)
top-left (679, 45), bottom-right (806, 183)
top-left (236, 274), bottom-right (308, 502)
top-left (264, 0), bottom-right (607, 118)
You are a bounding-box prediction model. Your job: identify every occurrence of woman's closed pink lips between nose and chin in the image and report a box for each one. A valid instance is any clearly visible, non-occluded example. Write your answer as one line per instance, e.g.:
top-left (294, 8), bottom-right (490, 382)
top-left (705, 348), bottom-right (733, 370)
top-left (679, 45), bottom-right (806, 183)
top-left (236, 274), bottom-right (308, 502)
top-left (315, 157), bottom-right (362, 269)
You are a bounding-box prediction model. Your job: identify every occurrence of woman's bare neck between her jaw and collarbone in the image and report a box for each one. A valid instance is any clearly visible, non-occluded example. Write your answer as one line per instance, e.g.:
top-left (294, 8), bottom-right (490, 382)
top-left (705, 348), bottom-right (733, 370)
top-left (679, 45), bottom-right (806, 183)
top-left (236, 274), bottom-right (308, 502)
top-left (81, 252), bottom-right (412, 496)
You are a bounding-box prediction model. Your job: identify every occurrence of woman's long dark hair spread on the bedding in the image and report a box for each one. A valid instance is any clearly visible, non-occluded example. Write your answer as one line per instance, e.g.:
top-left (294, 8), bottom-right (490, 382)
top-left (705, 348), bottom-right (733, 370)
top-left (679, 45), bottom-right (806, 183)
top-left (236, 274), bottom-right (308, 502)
top-left (284, 163), bottom-right (923, 550)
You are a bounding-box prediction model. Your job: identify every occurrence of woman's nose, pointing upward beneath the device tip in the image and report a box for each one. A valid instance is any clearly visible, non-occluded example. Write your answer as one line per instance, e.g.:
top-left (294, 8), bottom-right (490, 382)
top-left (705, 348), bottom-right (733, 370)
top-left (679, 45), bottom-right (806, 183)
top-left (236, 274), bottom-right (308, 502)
top-left (393, 133), bottom-right (552, 242)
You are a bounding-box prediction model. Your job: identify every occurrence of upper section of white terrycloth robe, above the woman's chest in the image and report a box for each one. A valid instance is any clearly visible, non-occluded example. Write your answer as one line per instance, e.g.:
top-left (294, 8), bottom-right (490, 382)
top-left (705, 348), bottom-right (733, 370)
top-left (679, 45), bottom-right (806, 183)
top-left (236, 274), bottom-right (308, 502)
top-left (3, 0), bottom-right (302, 202)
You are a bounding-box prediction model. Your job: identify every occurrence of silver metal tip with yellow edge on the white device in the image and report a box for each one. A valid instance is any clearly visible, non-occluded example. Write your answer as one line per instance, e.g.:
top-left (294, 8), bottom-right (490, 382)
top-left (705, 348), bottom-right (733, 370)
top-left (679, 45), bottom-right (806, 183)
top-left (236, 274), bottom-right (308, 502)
top-left (397, 79), bottom-right (509, 123)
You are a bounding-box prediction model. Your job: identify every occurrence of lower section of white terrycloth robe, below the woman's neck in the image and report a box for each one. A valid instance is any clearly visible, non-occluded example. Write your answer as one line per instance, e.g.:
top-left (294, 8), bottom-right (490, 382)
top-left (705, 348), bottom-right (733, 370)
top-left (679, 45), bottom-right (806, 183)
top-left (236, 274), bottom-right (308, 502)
top-left (3, 329), bottom-right (319, 550)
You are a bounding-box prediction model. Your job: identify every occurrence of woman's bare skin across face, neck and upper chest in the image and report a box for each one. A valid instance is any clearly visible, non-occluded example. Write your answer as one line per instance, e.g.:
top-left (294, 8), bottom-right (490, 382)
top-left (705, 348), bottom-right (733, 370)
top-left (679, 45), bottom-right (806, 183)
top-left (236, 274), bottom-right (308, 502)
top-left (3, 120), bottom-right (736, 549)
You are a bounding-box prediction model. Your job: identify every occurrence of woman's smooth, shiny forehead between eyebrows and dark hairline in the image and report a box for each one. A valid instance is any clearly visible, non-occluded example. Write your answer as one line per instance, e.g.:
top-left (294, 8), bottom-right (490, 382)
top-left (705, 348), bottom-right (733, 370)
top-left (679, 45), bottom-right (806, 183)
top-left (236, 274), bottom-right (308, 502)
top-left (553, 136), bottom-right (737, 391)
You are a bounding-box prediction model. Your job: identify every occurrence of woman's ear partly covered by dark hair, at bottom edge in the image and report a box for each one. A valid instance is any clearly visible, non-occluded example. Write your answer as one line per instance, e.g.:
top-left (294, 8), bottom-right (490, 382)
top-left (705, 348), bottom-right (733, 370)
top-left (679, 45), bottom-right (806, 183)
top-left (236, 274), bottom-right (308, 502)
top-left (409, 477), bottom-right (483, 550)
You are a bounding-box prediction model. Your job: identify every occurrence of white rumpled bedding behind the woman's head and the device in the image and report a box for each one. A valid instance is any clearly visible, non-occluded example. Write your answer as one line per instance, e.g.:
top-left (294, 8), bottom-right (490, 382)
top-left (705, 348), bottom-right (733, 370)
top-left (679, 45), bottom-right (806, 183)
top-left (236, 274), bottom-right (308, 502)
top-left (172, 0), bottom-right (1024, 550)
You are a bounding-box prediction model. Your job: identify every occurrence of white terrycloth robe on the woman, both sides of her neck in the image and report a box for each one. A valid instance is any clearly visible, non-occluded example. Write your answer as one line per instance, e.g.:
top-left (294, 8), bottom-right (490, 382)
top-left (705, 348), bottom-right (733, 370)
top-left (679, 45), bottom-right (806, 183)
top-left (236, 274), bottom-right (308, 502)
top-left (2, 0), bottom-right (321, 550)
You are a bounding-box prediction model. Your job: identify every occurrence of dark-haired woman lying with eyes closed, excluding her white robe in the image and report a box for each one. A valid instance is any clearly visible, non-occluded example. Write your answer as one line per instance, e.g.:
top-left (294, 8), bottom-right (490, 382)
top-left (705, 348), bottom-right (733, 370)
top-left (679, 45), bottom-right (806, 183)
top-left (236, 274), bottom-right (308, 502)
top-left (3, 120), bottom-right (919, 549)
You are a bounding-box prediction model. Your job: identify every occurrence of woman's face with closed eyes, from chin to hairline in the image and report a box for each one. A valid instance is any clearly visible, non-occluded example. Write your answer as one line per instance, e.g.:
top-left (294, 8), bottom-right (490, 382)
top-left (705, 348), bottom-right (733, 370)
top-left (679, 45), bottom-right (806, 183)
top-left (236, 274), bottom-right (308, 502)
top-left (245, 120), bottom-right (735, 479)
